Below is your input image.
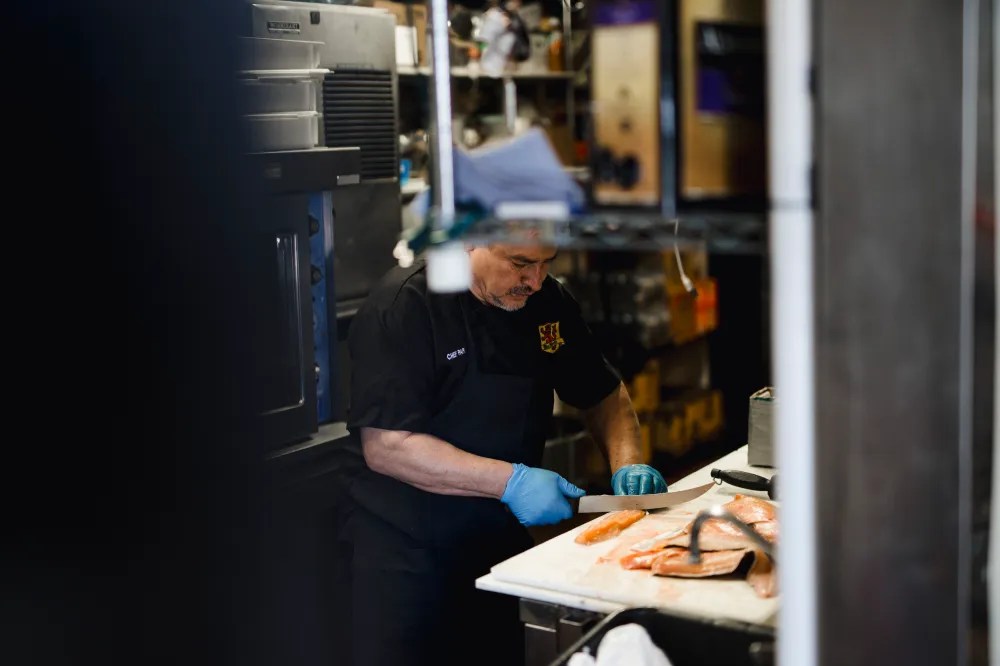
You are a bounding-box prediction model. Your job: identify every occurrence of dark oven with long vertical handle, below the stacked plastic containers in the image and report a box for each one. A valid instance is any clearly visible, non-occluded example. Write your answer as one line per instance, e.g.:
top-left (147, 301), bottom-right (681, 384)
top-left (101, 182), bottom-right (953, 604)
top-left (247, 148), bottom-right (361, 451)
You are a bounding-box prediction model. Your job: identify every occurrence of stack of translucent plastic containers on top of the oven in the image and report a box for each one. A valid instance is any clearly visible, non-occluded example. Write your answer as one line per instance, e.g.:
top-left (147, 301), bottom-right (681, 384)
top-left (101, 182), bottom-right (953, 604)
top-left (240, 37), bottom-right (330, 152)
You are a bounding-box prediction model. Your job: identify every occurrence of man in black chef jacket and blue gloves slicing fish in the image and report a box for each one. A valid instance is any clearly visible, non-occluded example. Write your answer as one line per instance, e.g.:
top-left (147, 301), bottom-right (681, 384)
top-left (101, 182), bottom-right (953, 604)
top-left (342, 245), bottom-right (666, 666)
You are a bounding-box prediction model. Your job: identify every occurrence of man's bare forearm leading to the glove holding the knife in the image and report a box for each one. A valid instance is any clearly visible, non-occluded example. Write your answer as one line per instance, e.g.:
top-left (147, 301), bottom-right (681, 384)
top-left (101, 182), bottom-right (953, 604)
top-left (361, 428), bottom-right (513, 499)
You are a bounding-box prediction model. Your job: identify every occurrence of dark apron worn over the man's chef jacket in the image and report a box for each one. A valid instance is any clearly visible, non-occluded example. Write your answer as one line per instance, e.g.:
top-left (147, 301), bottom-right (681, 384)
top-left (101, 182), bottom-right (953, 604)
top-left (338, 295), bottom-right (552, 666)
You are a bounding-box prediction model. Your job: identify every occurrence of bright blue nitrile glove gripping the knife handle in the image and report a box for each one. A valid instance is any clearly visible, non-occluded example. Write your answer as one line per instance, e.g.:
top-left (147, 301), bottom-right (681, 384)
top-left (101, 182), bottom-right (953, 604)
top-left (500, 463), bottom-right (587, 527)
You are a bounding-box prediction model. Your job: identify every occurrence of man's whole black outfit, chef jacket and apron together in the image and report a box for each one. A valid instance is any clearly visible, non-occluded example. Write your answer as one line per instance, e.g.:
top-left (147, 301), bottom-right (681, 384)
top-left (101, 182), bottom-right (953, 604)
top-left (338, 263), bottom-right (620, 666)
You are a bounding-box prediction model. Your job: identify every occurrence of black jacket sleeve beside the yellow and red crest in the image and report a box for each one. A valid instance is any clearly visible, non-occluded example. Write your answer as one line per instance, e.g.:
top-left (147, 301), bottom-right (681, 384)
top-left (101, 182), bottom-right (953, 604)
top-left (554, 285), bottom-right (621, 409)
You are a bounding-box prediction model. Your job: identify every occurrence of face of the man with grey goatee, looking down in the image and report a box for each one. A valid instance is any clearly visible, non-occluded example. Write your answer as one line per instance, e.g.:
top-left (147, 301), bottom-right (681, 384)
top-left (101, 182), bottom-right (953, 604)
top-left (469, 245), bottom-right (556, 312)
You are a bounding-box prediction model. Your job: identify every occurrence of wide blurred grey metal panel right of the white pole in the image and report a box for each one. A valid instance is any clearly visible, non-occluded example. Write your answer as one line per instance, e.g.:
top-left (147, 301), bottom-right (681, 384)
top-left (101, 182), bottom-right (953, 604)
top-left (816, 0), bottom-right (976, 666)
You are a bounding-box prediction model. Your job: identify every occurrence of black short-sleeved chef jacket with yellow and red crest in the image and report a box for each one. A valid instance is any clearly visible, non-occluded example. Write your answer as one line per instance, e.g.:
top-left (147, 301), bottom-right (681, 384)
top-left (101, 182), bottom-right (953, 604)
top-left (348, 255), bottom-right (621, 432)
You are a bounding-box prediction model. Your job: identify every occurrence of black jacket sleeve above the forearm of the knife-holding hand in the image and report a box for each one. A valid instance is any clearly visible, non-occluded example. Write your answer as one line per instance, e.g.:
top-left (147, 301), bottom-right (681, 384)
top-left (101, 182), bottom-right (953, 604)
top-left (348, 284), bottom-right (434, 432)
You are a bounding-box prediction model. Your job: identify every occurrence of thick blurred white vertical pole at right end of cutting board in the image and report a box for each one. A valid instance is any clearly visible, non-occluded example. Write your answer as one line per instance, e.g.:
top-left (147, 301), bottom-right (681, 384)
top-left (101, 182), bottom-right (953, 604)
top-left (767, 0), bottom-right (819, 666)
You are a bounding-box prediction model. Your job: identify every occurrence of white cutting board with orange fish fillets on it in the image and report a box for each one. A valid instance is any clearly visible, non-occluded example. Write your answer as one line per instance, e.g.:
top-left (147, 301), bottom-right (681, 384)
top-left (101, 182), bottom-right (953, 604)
top-left (491, 448), bottom-right (781, 626)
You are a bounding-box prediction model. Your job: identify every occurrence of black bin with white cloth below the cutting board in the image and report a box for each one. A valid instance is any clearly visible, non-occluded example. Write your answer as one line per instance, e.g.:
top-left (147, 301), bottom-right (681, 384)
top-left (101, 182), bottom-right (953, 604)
top-left (550, 608), bottom-right (775, 666)
